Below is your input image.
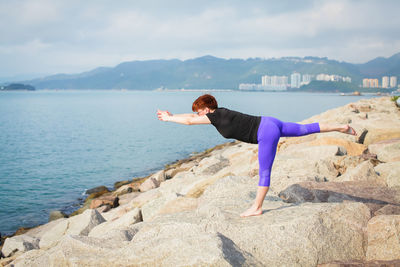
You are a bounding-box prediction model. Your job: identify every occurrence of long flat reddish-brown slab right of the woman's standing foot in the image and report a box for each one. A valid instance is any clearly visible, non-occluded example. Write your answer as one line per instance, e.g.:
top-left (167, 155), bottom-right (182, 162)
top-left (279, 182), bottom-right (400, 205)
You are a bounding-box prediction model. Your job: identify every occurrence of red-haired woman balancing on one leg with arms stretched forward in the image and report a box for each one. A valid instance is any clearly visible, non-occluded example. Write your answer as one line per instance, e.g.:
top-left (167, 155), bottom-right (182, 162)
top-left (157, 94), bottom-right (356, 217)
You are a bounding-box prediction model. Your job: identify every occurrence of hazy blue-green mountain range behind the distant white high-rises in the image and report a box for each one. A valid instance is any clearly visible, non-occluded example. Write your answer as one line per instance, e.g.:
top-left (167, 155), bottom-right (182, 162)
top-left (23, 53), bottom-right (400, 90)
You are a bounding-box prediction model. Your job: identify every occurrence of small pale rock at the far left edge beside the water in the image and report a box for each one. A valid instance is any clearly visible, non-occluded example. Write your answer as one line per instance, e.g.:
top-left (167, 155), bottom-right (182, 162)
top-left (1, 234), bottom-right (39, 257)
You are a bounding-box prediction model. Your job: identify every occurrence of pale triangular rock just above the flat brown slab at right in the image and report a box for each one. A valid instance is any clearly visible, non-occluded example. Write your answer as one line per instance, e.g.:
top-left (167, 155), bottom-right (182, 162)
top-left (335, 161), bottom-right (386, 186)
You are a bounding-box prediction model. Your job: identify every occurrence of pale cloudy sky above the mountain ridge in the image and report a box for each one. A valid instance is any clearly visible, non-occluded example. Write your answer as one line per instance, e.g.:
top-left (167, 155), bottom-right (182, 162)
top-left (0, 0), bottom-right (400, 77)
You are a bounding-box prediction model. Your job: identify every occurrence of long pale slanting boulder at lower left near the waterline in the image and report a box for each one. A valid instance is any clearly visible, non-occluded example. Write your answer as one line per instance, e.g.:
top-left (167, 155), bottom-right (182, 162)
top-left (39, 210), bottom-right (105, 248)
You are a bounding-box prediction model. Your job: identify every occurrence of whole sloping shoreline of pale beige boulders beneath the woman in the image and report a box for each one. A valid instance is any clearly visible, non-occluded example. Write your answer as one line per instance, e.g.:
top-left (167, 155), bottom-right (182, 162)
top-left (0, 97), bottom-right (400, 266)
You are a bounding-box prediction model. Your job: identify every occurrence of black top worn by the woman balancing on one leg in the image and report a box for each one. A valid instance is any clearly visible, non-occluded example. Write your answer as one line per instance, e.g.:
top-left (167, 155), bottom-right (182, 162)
top-left (206, 108), bottom-right (261, 144)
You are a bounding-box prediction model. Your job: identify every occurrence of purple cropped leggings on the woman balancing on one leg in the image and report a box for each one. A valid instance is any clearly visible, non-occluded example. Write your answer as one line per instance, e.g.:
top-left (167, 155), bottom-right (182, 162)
top-left (257, 117), bottom-right (320, 186)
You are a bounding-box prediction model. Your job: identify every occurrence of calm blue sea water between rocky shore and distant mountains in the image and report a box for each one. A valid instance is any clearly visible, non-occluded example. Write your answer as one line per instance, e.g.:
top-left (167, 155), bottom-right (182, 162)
top-left (0, 91), bottom-right (376, 236)
